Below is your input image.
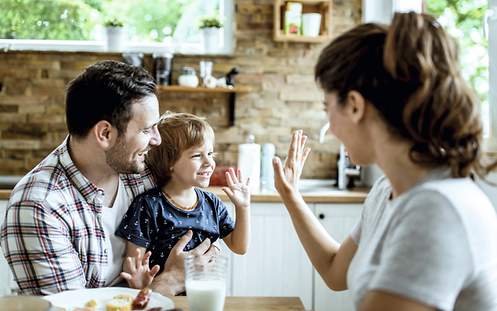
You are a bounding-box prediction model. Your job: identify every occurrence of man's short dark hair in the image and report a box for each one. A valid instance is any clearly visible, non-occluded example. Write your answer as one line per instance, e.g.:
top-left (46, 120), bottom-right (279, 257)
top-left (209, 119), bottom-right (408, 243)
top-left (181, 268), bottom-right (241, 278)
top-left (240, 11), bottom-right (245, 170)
top-left (66, 61), bottom-right (156, 137)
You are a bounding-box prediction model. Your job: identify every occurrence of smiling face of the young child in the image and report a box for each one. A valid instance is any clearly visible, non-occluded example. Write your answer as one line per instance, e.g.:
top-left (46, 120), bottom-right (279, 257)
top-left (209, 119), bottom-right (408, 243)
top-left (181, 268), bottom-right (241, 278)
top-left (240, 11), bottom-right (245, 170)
top-left (171, 140), bottom-right (216, 188)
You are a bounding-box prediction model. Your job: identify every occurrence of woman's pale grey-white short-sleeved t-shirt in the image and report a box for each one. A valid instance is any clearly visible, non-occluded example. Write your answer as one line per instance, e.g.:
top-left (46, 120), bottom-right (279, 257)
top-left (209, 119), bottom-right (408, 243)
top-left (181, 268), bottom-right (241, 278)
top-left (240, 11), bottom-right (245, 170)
top-left (347, 170), bottom-right (497, 311)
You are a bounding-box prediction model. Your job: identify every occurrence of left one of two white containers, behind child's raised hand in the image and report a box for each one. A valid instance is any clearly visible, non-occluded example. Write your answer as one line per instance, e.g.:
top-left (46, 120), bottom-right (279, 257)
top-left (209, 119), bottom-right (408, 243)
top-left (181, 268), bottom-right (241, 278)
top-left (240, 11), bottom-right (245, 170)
top-left (238, 135), bottom-right (261, 193)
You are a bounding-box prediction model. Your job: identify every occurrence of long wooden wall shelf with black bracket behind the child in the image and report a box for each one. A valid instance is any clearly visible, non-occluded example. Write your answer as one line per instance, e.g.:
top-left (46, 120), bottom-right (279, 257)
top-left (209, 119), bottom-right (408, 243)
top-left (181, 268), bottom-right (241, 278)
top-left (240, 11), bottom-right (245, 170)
top-left (158, 85), bottom-right (252, 126)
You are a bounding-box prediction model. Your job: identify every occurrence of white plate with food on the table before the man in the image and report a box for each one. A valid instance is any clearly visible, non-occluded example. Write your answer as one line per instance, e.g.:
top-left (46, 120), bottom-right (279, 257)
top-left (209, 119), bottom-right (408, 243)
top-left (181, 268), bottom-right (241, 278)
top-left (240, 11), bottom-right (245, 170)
top-left (44, 287), bottom-right (174, 311)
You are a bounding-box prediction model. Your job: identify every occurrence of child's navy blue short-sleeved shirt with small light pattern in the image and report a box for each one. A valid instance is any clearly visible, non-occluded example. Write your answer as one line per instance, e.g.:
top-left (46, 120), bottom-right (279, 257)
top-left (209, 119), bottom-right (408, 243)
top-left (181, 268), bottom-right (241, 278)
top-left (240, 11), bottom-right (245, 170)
top-left (116, 187), bottom-right (234, 271)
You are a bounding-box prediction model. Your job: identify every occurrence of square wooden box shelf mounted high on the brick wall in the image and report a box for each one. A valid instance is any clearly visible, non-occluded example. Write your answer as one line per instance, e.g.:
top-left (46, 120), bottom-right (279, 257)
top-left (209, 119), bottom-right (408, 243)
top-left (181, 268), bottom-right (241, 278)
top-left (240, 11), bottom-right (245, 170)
top-left (273, 0), bottom-right (332, 43)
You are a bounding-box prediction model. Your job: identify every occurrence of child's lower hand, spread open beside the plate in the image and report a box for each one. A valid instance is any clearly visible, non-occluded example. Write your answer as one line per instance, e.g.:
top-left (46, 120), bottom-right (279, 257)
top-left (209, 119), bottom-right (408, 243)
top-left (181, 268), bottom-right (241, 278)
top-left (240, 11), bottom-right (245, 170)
top-left (121, 249), bottom-right (160, 289)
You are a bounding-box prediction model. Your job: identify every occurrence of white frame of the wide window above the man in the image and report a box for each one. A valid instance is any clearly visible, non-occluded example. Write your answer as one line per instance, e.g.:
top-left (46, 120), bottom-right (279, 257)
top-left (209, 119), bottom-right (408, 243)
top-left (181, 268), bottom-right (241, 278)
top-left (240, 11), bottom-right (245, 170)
top-left (0, 0), bottom-right (236, 55)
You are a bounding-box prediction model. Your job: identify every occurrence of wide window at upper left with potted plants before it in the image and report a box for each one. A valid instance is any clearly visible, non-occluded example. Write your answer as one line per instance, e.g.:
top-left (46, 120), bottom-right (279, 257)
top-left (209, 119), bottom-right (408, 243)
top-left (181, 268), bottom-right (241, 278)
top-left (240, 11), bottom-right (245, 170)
top-left (0, 0), bottom-right (234, 54)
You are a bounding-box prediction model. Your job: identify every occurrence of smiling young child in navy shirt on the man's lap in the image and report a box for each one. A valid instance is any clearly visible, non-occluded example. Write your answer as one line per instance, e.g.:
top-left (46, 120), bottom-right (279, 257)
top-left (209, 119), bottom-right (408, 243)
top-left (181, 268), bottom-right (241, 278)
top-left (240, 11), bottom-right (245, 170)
top-left (116, 113), bottom-right (250, 289)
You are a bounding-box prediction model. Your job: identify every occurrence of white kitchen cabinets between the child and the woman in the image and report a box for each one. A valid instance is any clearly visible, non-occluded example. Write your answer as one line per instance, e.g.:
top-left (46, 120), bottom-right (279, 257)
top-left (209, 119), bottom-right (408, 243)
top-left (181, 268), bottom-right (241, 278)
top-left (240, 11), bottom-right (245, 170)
top-left (228, 203), bottom-right (362, 311)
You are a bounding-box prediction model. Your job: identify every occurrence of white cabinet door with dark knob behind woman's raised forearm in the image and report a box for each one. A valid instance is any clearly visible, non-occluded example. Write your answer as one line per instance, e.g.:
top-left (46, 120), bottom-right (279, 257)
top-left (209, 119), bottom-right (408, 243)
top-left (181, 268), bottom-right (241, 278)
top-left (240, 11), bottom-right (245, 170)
top-left (314, 204), bottom-right (362, 311)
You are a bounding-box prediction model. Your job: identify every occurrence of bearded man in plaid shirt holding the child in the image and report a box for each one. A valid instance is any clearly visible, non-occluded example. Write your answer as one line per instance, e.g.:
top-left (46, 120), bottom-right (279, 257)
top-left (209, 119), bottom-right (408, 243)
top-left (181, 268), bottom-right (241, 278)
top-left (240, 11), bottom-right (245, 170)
top-left (1, 61), bottom-right (217, 295)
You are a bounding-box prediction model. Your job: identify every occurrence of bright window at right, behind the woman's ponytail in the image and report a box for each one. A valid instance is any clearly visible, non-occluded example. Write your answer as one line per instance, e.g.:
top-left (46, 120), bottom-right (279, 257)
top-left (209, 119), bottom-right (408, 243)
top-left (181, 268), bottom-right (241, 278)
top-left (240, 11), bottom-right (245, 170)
top-left (363, 0), bottom-right (497, 151)
